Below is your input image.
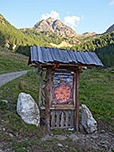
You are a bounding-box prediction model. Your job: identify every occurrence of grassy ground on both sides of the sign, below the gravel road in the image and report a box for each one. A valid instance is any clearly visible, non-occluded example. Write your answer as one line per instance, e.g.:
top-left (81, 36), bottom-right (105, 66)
top-left (0, 68), bottom-right (114, 152)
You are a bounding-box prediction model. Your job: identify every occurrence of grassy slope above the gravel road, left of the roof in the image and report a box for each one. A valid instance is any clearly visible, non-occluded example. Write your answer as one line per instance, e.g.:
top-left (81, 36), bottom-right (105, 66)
top-left (0, 47), bottom-right (31, 74)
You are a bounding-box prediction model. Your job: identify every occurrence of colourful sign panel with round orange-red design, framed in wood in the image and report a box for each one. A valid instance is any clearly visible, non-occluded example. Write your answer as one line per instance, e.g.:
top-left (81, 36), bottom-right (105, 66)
top-left (52, 72), bottom-right (73, 104)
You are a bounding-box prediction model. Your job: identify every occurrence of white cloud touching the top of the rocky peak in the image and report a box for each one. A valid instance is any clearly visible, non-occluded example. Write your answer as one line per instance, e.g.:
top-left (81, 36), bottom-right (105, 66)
top-left (41, 11), bottom-right (60, 19)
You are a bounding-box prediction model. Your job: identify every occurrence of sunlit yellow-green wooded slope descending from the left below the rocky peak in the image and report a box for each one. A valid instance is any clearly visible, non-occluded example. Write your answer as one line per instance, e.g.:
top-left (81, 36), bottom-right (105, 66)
top-left (0, 14), bottom-right (62, 50)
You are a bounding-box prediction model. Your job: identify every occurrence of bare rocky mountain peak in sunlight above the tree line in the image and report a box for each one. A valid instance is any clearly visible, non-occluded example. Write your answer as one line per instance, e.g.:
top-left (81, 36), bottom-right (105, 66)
top-left (33, 17), bottom-right (77, 37)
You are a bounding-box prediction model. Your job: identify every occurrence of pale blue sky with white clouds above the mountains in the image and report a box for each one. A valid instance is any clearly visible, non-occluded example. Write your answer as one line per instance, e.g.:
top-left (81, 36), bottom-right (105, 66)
top-left (0, 0), bottom-right (114, 34)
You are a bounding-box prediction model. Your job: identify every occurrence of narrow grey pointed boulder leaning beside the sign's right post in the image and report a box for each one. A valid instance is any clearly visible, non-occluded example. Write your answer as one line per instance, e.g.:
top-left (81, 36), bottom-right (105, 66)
top-left (81, 104), bottom-right (97, 133)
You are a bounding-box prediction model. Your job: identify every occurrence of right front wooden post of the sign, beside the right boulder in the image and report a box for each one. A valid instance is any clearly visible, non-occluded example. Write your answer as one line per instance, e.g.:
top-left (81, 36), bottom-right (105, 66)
top-left (75, 70), bottom-right (79, 131)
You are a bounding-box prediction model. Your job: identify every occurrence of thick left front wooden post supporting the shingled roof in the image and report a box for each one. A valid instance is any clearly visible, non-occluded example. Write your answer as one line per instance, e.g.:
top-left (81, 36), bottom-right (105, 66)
top-left (45, 67), bottom-right (52, 132)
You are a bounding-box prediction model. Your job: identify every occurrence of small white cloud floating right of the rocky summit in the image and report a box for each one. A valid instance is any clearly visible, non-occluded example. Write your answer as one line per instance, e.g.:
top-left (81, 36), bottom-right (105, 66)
top-left (64, 16), bottom-right (80, 28)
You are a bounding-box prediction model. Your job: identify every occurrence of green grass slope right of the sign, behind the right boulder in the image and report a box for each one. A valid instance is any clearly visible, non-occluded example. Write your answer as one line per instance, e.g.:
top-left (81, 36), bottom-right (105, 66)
top-left (80, 67), bottom-right (114, 128)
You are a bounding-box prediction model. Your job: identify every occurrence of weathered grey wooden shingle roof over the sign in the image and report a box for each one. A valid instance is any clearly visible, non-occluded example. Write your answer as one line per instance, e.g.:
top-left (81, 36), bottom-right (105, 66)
top-left (29, 46), bottom-right (103, 66)
